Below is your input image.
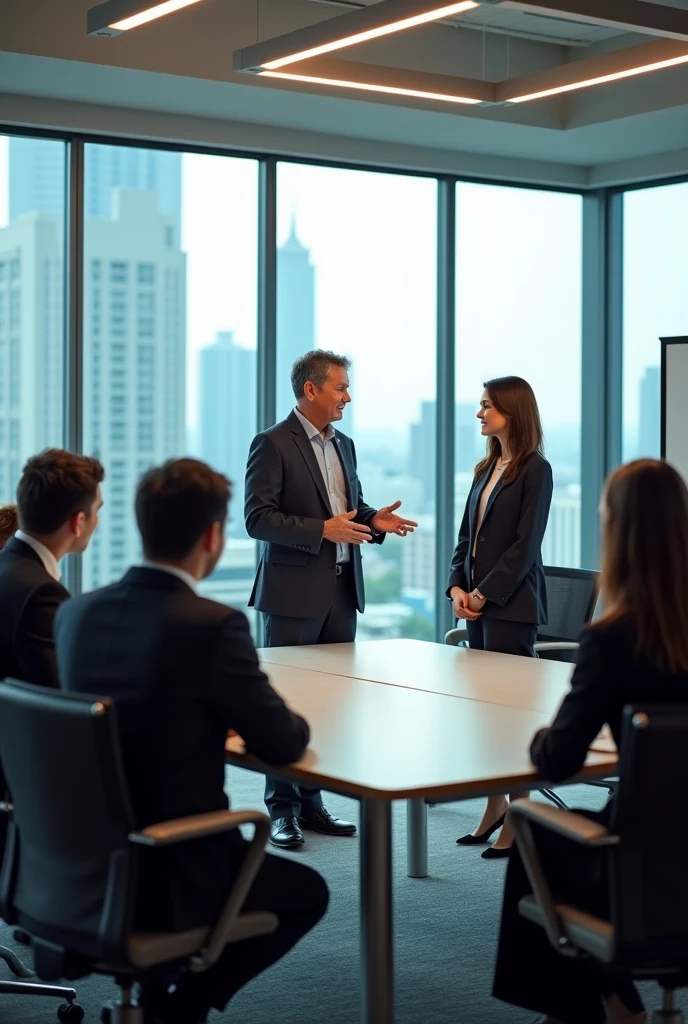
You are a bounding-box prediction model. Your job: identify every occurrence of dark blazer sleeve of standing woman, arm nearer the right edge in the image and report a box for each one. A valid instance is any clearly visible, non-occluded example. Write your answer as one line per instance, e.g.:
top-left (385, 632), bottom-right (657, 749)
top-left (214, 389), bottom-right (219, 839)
top-left (476, 460), bottom-right (552, 607)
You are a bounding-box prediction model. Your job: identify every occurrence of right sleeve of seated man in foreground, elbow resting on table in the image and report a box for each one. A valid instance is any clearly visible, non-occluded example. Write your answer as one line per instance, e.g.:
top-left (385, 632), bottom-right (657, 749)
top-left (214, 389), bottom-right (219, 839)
top-left (206, 611), bottom-right (310, 764)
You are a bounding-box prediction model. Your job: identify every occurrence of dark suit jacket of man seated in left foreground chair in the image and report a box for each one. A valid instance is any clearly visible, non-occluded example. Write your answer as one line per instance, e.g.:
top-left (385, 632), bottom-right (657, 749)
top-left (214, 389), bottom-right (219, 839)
top-left (55, 567), bottom-right (309, 931)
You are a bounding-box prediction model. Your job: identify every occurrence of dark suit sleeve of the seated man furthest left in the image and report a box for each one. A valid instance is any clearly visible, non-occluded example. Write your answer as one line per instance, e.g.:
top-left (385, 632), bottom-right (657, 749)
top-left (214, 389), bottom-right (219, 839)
top-left (14, 582), bottom-right (70, 686)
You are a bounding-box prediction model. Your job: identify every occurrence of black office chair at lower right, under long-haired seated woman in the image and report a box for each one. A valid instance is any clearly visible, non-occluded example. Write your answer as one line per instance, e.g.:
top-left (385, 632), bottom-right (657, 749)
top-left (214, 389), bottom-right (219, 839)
top-left (509, 705), bottom-right (688, 1024)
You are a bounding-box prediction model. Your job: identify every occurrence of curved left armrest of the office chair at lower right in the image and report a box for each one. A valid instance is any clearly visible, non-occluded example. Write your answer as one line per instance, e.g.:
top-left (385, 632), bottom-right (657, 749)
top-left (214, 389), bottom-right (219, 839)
top-left (507, 800), bottom-right (618, 956)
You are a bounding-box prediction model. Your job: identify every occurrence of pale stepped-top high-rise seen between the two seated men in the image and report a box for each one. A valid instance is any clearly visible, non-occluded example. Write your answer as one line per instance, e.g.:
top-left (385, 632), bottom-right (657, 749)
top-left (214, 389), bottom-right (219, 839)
top-left (84, 189), bottom-right (186, 589)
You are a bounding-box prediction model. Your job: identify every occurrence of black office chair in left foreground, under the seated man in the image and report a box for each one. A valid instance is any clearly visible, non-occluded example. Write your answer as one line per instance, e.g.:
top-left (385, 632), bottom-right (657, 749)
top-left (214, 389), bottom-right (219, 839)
top-left (0, 680), bottom-right (277, 1024)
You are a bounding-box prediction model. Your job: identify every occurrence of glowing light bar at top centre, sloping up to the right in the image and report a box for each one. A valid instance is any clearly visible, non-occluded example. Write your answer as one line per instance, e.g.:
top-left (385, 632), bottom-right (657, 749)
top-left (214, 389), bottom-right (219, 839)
top-left (234, 0), bottom-right (479, 75)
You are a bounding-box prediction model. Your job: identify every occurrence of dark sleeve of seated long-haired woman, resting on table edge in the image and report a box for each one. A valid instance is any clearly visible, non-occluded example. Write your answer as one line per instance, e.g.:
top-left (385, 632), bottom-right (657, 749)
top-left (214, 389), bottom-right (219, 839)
top-left (530, 627), bottom-right (616, 782)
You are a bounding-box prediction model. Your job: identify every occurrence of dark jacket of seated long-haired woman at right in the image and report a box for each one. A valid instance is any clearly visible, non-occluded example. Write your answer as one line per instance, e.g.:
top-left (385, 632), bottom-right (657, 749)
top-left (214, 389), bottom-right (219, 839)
top-left (530, 618), bottom-right (688, 819)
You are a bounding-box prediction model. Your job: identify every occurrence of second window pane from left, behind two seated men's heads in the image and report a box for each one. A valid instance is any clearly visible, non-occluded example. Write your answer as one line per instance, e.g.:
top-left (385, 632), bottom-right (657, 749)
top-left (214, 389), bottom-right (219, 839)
top-left (84, 144), bottom-right (258, 622)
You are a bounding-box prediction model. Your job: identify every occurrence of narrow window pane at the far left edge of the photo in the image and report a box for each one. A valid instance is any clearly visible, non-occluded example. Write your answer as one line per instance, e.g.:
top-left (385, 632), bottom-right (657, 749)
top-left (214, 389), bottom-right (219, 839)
top-left (0, 135), bottom-right (67, 503)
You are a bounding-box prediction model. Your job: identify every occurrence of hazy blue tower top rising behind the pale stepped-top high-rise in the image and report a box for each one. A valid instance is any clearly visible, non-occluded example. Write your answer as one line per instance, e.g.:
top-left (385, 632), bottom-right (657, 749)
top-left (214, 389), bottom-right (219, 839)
top-left (9, 136), bottom-right (181, 238)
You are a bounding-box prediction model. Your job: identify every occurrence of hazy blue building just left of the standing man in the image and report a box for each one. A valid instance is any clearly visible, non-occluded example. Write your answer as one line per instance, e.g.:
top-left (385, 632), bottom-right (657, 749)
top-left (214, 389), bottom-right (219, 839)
top-left (199, 331), bottom-right (256, 537)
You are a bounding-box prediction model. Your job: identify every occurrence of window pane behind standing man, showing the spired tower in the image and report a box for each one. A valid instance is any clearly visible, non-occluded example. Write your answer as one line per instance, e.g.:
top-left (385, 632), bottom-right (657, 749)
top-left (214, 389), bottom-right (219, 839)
top-left (277, 164), bottom-right (437, 640)
